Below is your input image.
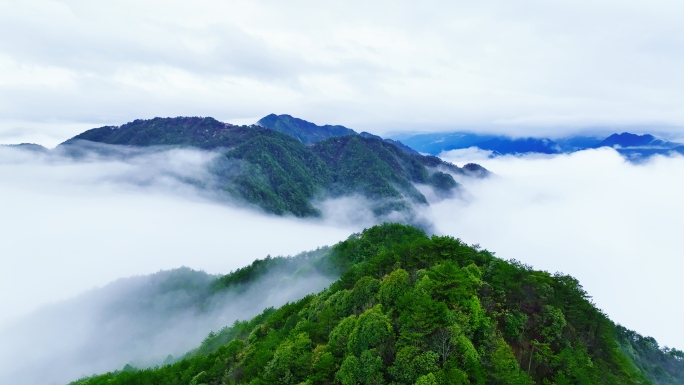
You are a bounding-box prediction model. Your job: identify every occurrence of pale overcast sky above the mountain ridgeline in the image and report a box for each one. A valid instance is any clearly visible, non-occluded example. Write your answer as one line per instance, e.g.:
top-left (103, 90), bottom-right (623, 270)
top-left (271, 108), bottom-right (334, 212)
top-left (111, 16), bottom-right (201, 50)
top-left (0, 0), bottom-right (684, 146)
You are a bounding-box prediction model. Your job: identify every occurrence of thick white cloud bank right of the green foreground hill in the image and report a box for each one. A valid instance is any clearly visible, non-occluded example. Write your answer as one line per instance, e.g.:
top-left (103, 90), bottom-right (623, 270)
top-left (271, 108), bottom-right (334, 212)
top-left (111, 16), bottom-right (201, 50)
top-left (426, 149), bottom-right (684, 349)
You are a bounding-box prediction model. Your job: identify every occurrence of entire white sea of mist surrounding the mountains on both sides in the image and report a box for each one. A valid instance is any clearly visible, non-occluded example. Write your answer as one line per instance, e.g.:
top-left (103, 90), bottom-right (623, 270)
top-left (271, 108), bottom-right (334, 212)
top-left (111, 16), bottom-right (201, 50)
top-left (0, 142), bottom-right (684, 384)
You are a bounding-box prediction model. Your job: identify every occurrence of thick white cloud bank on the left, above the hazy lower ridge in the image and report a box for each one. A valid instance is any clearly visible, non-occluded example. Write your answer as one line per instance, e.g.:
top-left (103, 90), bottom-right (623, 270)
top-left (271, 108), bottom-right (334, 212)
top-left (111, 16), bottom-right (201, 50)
top-left (0, 148), bottom-right (358, 325)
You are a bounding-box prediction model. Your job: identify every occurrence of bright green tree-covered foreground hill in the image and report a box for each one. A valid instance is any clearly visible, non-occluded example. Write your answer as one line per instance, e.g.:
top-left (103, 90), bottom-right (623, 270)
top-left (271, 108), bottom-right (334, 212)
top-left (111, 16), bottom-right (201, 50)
top-left (73, 224), bottom-right (684, 385)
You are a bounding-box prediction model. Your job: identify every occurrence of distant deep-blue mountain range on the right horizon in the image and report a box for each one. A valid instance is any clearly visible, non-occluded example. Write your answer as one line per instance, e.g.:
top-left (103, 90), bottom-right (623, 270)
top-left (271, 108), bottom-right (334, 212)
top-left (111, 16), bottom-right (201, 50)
top-left (402, 132), bottom-right (684, 161)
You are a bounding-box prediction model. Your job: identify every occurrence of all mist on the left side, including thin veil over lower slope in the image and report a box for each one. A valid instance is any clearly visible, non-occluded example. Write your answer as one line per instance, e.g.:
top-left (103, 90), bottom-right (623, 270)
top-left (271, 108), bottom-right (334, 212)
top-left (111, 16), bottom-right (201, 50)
top-left (0, 146), bottom-right (358, 384)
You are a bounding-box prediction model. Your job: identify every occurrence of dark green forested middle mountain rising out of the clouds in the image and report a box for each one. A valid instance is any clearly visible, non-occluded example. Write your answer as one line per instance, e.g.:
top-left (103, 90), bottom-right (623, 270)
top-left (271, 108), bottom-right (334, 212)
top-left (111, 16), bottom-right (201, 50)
top-left (61, 117), bottom-right (487, 217)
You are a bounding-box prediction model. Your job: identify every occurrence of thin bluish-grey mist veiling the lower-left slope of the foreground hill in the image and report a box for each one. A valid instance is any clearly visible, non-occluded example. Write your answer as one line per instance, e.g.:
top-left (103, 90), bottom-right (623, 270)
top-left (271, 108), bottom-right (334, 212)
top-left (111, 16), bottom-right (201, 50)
top-left (0, 268), bottom-right (332, 384)
